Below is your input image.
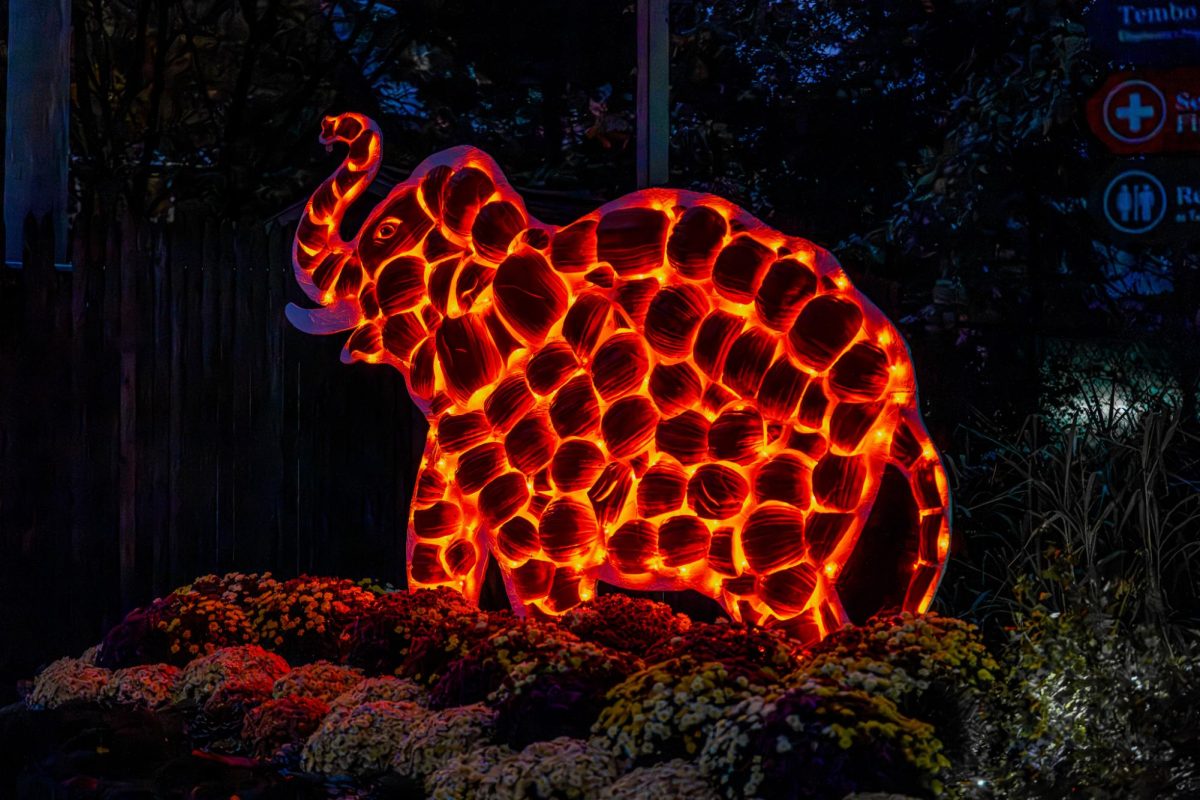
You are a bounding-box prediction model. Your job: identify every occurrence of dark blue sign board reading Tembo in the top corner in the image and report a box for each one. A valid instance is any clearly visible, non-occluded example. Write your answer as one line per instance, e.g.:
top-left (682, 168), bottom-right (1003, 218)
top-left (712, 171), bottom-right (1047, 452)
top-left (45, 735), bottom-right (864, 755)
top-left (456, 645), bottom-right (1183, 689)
top-left (1086, 0), bottom-right (1200, 66)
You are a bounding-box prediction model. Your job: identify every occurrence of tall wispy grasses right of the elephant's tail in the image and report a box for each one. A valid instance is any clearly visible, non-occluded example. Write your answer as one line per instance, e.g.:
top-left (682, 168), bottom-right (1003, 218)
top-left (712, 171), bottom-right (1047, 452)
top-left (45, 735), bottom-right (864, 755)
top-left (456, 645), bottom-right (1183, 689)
top-left (942, 411), bottom-right (1200, 639)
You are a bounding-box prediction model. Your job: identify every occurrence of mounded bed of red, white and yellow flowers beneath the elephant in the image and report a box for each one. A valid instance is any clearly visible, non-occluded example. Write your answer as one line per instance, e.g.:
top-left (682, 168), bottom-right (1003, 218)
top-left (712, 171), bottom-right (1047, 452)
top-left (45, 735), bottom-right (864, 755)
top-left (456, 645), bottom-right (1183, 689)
top-left (9, 575), bottom-right (1123, 800)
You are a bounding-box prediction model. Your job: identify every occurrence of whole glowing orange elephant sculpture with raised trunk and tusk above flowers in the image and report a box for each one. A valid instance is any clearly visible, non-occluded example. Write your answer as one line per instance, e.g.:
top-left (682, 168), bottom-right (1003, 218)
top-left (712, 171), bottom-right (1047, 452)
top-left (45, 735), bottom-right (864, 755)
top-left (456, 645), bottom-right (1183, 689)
top-left (288, 114), bottom-right (949, 640)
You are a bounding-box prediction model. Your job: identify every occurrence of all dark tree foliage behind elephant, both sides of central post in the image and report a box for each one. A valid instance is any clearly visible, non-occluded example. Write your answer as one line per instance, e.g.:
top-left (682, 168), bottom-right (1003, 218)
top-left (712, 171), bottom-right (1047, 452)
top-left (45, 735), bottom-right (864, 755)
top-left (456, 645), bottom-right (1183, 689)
top-left (72, 0), bottom-right (1200, 424)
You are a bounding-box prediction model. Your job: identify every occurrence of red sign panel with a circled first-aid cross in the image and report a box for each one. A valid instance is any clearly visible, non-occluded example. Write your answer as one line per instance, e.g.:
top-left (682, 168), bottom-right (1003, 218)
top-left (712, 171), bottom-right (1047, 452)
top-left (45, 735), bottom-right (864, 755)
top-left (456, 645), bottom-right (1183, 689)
top-left (1087, 67), bottom-right (1200, 154)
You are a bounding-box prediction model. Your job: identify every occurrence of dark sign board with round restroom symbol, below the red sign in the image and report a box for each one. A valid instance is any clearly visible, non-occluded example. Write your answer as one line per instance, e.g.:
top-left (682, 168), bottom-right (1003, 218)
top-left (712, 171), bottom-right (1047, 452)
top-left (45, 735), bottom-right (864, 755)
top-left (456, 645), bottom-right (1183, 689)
top-left (1087, 158), bottom-right (1200, 242)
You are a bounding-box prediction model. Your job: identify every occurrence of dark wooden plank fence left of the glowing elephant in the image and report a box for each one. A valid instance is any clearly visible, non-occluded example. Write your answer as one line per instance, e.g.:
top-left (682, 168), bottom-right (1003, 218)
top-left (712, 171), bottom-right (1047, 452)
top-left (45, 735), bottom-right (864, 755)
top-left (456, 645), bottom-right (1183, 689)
top-left (0, 216), bottom-right (425, 699)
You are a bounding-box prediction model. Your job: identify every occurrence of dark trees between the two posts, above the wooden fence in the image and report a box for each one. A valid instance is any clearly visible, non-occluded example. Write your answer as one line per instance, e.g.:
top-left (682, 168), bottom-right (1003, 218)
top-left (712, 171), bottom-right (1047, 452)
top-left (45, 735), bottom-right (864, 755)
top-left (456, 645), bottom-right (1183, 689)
top-left (72, 0), bottom-right (634, 219)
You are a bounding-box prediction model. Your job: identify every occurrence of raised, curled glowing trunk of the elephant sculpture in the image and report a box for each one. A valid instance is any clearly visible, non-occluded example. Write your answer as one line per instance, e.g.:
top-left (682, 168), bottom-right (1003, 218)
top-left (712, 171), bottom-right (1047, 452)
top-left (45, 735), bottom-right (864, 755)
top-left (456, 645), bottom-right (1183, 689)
top-left (292, 114), bottom-right (383, 311)
